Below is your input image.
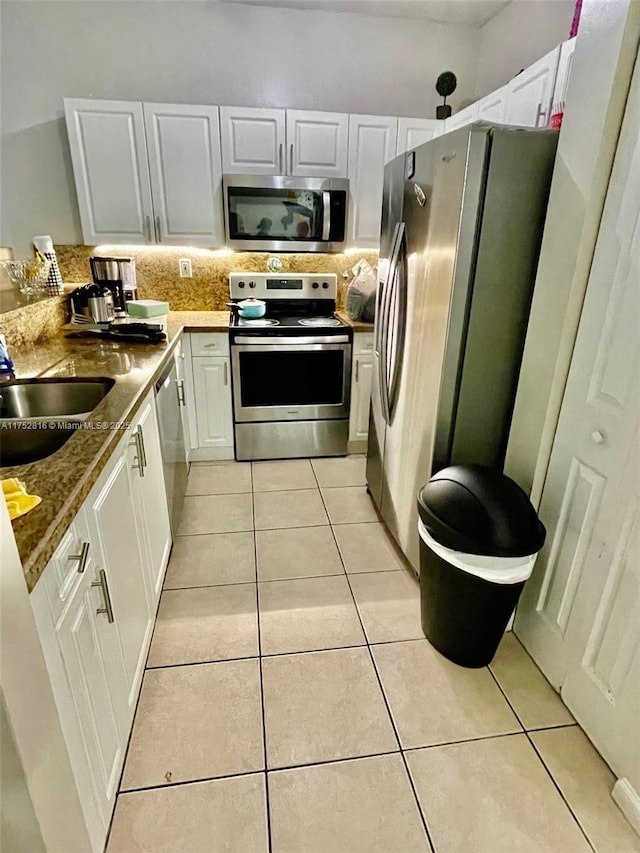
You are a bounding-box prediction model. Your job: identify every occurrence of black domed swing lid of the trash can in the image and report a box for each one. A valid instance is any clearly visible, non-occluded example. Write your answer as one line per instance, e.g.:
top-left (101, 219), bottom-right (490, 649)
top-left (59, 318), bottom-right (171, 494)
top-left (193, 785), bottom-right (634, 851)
top-left (418, 465), bottom-right (546, 557)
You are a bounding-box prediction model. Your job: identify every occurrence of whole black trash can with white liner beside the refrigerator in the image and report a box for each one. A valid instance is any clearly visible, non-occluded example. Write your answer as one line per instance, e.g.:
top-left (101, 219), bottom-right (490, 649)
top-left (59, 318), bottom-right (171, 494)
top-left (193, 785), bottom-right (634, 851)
top-left (418, 465), bottom-right (546, 667)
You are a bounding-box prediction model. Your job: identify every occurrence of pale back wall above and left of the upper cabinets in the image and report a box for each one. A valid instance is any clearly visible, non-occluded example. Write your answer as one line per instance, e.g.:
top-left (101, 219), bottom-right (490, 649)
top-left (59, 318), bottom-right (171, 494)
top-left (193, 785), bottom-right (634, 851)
top-left (0, 0), bottom-right (477, 256)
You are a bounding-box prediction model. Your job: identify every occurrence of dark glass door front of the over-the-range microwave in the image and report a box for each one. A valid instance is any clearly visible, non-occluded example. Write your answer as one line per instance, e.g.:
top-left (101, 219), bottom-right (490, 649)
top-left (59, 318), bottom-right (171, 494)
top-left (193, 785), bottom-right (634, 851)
top-left (227, 187), bottom-right (346, 243)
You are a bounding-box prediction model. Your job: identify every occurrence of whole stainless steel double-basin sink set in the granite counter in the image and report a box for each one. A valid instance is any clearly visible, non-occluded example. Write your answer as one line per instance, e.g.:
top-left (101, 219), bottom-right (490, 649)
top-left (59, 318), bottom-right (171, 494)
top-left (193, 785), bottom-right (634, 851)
top-left (0, 378), bottom-right (115, 468)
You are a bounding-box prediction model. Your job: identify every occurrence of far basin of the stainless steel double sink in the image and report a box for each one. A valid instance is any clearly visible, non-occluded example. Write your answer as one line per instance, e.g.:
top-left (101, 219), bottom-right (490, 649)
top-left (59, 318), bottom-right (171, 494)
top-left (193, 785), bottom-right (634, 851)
top-left (0, 379), bottom-right (114, 418)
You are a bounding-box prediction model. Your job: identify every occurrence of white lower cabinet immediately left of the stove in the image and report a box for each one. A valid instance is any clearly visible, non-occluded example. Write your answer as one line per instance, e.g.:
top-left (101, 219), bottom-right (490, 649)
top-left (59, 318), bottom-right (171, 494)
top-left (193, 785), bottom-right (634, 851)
top-left (185, 332), bottom-right (233, 462)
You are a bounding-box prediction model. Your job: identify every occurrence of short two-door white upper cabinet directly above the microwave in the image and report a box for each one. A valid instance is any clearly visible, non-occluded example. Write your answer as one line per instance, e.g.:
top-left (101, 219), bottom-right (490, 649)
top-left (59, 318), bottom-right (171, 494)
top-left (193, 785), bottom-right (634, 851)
top-left (220, 107), bottom-right (349, 178)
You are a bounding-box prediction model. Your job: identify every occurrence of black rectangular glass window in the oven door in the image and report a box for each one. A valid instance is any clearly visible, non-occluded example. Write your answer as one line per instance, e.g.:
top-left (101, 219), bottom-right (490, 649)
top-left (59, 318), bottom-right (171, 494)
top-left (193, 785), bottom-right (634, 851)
top-left (239, 349), bottom-right (345, 408)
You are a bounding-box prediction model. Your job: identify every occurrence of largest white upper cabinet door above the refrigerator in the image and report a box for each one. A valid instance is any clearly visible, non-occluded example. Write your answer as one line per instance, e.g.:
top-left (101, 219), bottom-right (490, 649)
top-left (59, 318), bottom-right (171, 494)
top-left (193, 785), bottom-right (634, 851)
top-left (504, 47), bottom-right (560, 127)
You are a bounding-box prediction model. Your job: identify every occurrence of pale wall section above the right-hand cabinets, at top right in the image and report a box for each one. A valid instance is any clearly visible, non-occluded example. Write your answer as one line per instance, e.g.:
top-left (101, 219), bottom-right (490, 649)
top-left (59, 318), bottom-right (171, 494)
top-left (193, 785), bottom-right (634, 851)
top-left (475, 0), bottom-right (575, 97)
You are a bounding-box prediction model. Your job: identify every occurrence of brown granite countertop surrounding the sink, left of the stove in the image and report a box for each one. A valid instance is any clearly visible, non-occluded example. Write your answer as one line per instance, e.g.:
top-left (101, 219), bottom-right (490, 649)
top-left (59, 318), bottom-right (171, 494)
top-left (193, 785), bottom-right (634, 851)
top-left (0, 311), bottom-right (229, 592)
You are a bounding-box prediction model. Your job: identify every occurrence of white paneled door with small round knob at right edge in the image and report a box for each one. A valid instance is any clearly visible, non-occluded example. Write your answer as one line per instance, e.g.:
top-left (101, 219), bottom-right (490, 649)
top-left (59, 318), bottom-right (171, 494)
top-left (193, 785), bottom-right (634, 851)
top-left (515, 58), bottom-right (640, 803)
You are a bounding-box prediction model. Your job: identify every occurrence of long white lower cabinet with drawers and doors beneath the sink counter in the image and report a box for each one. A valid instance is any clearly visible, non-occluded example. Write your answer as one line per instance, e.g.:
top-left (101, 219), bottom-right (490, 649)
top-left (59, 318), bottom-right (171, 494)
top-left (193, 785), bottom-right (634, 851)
top-left (31, 394), bottom-right (170, 851)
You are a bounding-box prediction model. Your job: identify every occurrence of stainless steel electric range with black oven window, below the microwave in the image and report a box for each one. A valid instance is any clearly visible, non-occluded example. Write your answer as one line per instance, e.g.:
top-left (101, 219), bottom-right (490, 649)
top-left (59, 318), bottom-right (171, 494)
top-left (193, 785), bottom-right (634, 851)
top-left (229, 272), bottom-right (353, 459)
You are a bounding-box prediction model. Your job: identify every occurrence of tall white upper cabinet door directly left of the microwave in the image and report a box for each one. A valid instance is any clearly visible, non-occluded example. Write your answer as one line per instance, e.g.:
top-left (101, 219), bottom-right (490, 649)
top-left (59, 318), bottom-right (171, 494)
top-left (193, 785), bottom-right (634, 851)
top-left (143, 104), bottom-right (224, 246)
